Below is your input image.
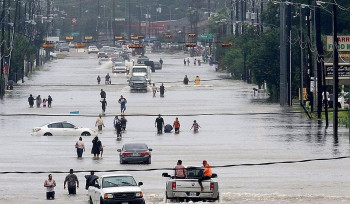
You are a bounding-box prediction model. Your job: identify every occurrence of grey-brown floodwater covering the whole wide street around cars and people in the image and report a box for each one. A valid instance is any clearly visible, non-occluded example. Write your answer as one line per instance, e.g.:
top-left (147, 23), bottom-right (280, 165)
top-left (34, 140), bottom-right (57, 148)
top-left (0, 51), bottom-right (350, 203)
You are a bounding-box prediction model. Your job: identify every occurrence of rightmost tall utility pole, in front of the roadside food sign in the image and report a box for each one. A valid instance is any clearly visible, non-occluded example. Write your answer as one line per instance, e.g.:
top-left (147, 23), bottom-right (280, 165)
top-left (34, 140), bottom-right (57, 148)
top-left (332, 0), bottom-right (339, 139)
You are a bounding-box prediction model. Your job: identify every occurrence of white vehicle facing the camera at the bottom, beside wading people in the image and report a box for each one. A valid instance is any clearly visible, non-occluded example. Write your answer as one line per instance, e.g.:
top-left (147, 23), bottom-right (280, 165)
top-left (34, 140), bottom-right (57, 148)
top-left (88, 174), bottom-right (145, 204)
